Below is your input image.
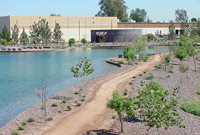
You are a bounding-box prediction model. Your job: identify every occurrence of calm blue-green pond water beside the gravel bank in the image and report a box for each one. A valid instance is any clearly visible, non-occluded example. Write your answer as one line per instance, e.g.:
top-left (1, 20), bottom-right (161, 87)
top-left (0, 47), bottom-right (170, 127)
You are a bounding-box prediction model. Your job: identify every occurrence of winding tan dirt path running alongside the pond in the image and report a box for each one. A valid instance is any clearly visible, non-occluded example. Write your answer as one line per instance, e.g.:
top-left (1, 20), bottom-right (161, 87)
top-left (44, 55), bottom-right (160, 135)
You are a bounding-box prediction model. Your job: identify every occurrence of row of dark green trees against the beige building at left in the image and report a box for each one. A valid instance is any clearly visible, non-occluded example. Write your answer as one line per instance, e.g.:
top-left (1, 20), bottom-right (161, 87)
top-left (0, 19), bottom-right (65, 45)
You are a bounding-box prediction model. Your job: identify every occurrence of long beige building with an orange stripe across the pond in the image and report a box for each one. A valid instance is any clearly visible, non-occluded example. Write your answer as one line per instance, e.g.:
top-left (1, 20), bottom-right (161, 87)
top-left (0, 16), bottom-right (118, 41)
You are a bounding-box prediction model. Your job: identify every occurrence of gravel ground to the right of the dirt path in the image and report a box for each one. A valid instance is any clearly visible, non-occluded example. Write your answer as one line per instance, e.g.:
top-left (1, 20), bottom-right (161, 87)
top-left (111, 54), bottom-right (200, 135)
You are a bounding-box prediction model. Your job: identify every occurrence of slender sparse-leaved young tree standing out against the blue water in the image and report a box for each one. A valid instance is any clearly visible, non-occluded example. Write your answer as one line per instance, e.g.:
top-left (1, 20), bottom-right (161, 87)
top-left (70, 57), bottom-right (95, 93)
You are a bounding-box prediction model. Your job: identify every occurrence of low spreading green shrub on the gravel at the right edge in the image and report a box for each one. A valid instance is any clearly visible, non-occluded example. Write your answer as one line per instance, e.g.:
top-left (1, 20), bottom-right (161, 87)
top-left (181, 102), bottom-right (200, 116)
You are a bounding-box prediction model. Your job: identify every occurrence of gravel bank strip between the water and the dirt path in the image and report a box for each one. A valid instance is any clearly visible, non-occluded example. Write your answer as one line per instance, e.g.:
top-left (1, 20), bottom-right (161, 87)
top-left (0, 62), bottom-right (131, 135)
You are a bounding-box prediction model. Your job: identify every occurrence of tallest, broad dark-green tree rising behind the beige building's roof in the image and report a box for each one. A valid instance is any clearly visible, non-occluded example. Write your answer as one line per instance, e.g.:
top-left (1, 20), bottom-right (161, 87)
top-left (95, 0), bottom-right (128, 21)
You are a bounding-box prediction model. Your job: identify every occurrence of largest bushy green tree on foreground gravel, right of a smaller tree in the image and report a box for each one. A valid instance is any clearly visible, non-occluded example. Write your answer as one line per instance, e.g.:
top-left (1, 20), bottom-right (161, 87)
top-left (135, 81), bottom-right (182, 134)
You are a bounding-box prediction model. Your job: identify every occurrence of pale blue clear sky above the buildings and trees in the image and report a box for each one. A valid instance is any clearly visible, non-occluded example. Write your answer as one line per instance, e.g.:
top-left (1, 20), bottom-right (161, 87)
top-left (0, 0), bottom-right (200, 22)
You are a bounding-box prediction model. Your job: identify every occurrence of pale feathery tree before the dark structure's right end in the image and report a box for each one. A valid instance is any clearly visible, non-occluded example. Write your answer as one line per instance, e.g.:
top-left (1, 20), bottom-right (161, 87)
top-left (131, 37), bottom-right (146, 55)
